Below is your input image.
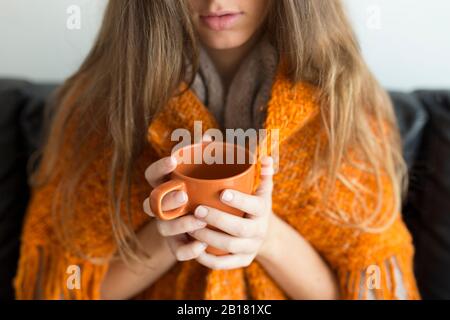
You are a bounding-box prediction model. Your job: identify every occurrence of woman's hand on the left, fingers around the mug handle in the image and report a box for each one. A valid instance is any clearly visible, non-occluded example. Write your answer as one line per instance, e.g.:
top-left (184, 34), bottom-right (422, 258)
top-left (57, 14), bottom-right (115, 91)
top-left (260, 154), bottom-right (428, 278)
top-left (144, 157), bottom-right (207, 261)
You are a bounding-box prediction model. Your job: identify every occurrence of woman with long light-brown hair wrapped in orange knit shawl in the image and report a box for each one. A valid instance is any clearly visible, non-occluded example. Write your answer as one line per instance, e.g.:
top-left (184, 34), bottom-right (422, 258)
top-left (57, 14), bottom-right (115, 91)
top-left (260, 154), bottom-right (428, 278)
top-left (15, 0), bottom-right (419, 299)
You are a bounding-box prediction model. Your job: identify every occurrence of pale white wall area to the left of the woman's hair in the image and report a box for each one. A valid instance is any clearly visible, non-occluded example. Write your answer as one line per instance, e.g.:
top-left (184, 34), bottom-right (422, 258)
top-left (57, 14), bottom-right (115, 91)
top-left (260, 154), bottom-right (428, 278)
top-left (0, 0), bottom-right (106, 81)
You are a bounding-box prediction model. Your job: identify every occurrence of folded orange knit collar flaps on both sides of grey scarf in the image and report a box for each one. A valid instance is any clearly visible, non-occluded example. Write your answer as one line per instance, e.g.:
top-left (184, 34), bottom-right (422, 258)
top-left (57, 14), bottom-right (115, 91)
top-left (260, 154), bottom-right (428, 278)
top-left (147, 64), bottom-right (319, 157)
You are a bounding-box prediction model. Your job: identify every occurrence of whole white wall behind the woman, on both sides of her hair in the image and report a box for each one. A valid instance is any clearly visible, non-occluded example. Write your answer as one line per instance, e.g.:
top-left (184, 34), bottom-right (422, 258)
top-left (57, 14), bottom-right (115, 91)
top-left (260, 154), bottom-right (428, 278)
top-left (0, 0), bottom-right (450, 90)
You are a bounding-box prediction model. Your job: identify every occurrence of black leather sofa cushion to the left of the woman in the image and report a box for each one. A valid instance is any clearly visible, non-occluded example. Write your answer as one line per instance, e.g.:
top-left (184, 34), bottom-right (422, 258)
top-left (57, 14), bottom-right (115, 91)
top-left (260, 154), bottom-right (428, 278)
top-left (0, 80), bottom-right (54, 300)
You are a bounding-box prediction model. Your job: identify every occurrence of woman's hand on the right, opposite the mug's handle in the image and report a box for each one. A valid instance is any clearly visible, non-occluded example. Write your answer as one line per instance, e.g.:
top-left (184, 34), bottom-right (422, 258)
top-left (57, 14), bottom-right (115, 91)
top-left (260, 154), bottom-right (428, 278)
top-left (189, 157), bottom-right (274, 269)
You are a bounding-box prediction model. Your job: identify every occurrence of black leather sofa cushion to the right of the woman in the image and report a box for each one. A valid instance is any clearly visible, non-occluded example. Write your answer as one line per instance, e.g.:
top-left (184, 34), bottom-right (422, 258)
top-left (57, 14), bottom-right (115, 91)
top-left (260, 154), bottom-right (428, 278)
top-left (405, 91), bottom-right (450, 299)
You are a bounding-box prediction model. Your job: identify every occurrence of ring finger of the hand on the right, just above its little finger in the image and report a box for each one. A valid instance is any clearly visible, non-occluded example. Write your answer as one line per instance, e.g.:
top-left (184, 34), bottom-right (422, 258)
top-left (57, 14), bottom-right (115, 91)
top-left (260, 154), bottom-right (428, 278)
top-left (189, 228), bottom-right (259, 254)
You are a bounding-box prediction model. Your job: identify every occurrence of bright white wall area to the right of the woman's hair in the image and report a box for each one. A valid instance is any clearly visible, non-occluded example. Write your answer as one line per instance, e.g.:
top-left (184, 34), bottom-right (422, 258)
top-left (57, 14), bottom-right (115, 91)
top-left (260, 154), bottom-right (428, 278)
top-left (345, 0), bottom-right (450, 89)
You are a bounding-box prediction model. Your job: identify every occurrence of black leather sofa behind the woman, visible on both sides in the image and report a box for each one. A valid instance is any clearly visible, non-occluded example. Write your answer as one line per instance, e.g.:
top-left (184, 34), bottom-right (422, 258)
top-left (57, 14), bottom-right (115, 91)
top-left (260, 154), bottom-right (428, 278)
top-left (0, 79), bottom-right (450, 300)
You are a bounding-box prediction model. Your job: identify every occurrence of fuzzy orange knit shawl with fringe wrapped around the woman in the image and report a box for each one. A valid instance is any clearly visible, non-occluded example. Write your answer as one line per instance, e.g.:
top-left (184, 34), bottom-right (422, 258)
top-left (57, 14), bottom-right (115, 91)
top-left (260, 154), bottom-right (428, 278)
top-left (15, 65), bottom-right (419, 299)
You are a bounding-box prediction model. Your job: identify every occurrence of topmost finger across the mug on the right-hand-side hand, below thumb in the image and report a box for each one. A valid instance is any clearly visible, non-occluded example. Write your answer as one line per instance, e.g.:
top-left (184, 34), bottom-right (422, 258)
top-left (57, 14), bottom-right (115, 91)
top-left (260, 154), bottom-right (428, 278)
top-left (220, 189), bottom-right (266, 216)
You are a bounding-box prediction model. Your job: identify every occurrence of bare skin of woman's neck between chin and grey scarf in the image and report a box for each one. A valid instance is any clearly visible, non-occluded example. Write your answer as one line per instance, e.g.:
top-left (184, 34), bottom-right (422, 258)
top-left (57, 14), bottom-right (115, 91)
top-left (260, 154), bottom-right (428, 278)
top-left (205, 36), bottom-right (259, 90)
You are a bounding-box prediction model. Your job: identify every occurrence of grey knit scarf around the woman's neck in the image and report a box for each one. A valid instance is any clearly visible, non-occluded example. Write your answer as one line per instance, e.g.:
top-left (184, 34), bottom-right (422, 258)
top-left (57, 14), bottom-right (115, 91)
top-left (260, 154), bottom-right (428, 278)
top-left (192, 37), bottom-right (278, 130)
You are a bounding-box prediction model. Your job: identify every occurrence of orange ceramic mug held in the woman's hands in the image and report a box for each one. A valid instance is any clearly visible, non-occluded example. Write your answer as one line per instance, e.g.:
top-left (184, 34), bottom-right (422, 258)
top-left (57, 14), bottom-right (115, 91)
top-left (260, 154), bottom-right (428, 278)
top-left (150, 142), bottom-right (256, 255)
